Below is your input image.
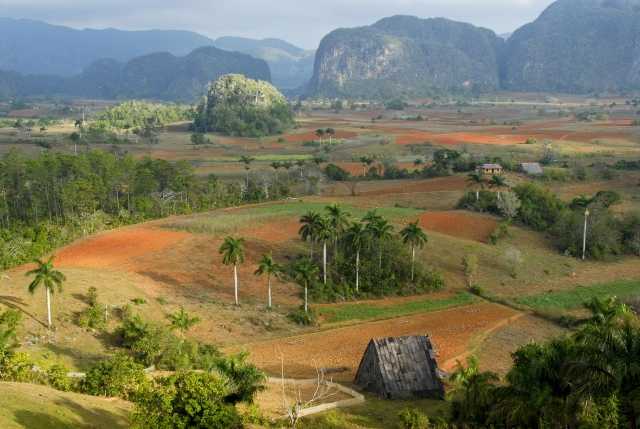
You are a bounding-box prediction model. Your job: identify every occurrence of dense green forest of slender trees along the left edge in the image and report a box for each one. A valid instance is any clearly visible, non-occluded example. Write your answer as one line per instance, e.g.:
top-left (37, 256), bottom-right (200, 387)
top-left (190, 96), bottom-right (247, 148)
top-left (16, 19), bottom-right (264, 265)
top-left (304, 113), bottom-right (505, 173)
top-left (0, 150), bottom-right (277, 268)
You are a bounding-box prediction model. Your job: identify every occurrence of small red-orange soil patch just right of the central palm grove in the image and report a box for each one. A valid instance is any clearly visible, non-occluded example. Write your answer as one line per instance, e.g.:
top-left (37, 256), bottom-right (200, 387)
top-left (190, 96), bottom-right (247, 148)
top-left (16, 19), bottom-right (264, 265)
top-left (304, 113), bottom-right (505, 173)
top-left (420, 211), bottom-right (498, 242)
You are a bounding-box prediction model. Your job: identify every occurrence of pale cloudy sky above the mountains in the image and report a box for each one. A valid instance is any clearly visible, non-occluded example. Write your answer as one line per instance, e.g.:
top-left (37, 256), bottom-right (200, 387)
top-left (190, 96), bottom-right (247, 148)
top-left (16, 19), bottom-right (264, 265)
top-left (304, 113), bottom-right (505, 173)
top-left (0, 0), bottom-right (552, 49)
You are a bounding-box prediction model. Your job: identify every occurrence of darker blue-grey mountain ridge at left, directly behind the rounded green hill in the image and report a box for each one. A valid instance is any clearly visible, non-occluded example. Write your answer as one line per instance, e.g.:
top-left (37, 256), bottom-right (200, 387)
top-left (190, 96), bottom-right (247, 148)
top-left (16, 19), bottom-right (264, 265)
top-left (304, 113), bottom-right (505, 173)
top-left (0, 46), bottom-right (271, 102)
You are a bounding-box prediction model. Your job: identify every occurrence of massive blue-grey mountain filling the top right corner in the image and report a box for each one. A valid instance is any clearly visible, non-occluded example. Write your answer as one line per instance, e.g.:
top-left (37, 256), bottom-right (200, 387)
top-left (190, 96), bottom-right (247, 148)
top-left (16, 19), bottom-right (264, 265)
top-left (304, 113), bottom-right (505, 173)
top-left (502, 0), bottom-right (640, 93)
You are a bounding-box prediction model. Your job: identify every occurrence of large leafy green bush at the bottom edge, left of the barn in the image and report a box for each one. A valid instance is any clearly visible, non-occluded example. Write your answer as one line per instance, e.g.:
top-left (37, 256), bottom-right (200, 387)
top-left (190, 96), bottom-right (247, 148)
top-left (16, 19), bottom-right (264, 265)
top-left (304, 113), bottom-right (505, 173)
top-left (133, 372), bottom-right (242, 429)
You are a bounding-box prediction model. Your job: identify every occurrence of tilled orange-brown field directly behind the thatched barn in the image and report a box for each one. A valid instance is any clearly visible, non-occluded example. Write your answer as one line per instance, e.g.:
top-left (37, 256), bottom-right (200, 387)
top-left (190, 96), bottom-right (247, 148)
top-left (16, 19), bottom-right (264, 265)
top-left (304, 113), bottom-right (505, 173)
top-left (240, 303), bottom-right (519, 382)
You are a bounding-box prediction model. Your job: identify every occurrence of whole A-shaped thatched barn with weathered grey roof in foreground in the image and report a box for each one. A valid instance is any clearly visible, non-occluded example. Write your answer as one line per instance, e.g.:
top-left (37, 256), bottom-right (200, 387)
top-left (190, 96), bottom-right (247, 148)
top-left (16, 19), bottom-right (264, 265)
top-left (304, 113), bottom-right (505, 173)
top-left (355, 336), bottom-right (444, 399)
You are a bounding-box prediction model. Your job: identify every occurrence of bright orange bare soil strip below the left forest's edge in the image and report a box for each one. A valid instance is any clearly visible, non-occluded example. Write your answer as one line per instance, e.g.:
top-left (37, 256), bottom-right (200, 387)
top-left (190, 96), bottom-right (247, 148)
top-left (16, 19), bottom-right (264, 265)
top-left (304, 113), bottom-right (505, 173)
top-left (56, 226), bottom-right (190, 268)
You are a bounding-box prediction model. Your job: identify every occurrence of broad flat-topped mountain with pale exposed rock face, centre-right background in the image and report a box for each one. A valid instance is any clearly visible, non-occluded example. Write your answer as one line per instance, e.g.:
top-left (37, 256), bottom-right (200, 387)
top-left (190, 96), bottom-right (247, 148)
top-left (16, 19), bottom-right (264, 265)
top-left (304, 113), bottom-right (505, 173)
top-left (309, 16), bottom-right (504, 97)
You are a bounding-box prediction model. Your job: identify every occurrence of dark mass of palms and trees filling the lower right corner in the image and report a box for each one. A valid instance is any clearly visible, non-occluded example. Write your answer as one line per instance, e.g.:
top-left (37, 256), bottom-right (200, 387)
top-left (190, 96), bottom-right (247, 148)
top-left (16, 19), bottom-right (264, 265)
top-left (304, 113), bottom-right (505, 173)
top-left (451, 298), bottom-right (640, 429)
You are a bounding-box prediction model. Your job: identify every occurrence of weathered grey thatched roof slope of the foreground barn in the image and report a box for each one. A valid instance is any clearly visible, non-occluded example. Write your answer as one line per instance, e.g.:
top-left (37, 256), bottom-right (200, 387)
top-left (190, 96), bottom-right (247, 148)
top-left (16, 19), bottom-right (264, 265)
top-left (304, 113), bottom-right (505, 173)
top-left (352, 336), bottom-right (443, 395)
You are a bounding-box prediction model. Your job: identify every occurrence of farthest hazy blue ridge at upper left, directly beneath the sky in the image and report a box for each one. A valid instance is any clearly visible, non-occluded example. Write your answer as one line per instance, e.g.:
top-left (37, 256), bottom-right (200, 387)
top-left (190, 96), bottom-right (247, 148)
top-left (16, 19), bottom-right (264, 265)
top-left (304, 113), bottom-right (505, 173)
top-left (0, 18), bottom-right (213, 76)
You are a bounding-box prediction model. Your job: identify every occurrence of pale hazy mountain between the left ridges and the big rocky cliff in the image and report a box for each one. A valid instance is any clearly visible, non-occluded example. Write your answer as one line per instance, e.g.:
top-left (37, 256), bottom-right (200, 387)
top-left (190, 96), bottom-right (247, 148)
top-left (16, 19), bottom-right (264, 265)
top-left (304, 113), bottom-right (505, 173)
top-left (215, 37), bottom-right (315, 90)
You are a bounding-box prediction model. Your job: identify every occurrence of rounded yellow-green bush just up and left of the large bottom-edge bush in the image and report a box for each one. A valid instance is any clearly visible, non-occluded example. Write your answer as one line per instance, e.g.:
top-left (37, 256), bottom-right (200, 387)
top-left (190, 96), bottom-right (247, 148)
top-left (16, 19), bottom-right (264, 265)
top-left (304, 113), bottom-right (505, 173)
top-left (80, 354), bottom-right (148, 400)
